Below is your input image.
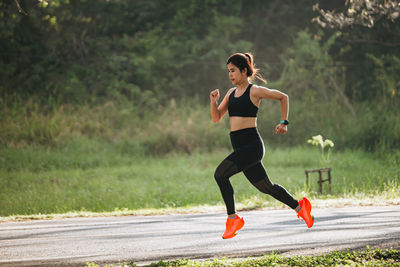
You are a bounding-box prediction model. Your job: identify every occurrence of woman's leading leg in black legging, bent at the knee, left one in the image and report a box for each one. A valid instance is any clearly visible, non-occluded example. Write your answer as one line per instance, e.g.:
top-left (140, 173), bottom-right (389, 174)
top-left (214, 158), bottom-right (240, 215)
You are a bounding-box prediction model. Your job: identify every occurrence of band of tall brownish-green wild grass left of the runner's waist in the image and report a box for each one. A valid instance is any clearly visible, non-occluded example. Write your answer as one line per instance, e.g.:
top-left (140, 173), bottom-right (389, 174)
top-left (0, 99), bottom-right (229, 155)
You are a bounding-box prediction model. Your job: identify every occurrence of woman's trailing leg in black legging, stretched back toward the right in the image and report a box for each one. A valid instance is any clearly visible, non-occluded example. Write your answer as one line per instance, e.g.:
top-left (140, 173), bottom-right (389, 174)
top-left (243, 162), bottom-right (299, 209)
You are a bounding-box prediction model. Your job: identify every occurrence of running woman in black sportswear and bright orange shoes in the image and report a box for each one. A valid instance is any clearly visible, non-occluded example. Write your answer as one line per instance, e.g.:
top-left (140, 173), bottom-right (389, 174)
top-left (210, 53), bottom-right (314, 239)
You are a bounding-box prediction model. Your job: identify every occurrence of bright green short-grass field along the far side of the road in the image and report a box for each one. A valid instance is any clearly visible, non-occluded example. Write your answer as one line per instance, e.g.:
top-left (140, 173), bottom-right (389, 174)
top-left (0, 139), bottom-right (400, 217)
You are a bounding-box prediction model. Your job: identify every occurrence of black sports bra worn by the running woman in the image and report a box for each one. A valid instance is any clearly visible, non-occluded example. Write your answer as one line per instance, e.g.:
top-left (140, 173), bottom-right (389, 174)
top-left (228, 84), bottom-right (258, 117)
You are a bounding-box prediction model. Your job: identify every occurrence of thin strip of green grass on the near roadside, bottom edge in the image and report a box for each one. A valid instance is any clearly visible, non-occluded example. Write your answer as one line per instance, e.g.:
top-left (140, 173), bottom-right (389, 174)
top-left (86, 248), bottom-right (400, 267)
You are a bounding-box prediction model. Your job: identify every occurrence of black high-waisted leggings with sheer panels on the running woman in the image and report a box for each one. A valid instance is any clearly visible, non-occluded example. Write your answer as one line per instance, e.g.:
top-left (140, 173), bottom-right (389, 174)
top-left (214, 128), bottom-right (298, 215)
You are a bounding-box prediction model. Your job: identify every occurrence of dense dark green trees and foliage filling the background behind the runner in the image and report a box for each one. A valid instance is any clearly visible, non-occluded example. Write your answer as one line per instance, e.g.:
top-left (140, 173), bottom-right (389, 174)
top-left (0, 0), bottom-right (400, 150)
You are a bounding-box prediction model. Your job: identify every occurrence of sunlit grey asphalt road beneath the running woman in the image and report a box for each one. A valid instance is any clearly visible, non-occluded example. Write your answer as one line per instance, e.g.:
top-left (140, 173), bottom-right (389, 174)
top-left (0, 206), bottom-right (400, 266)
